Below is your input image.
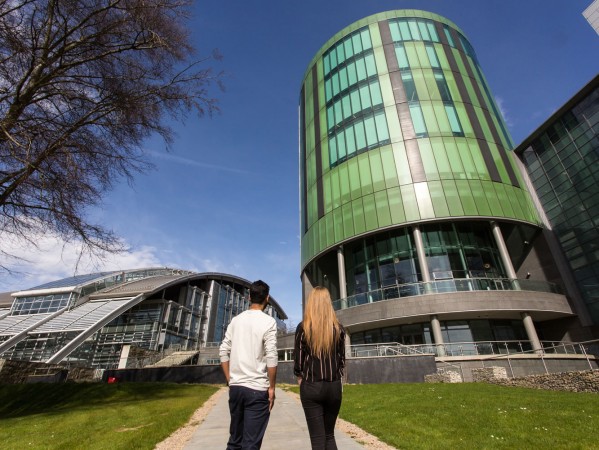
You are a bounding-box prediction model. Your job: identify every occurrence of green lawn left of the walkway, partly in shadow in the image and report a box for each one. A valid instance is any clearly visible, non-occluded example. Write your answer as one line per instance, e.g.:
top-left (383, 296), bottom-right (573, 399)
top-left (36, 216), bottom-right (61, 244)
top-left (0, 383), bottom-right (218, 450)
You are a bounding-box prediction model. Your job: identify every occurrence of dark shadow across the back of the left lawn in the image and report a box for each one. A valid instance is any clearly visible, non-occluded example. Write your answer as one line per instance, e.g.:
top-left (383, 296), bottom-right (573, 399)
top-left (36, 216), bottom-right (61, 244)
top-left (0, 383), bottom-right (211, 419)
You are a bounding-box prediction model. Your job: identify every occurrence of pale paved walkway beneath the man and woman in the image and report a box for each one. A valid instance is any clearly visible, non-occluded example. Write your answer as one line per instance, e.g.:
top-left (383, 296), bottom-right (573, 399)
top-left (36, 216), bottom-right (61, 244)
top-left (184, 389), bottom-right (364, 450)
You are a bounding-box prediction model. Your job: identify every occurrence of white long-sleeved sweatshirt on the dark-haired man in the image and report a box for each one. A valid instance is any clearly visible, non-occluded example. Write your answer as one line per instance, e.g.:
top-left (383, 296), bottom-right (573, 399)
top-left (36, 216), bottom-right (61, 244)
top-left (219, 309), bottom-right (278, 391)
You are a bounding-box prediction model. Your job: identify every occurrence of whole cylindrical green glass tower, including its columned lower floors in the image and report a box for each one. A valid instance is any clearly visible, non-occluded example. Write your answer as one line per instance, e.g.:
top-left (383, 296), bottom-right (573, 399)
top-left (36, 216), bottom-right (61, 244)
top-left (299, 10), bottom-right (582, 356)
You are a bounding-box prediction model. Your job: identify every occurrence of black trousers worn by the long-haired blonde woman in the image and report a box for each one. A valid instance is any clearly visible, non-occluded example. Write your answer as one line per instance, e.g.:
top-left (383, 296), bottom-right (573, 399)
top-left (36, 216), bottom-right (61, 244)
top-left (300, 380), bottom-right (342, 450)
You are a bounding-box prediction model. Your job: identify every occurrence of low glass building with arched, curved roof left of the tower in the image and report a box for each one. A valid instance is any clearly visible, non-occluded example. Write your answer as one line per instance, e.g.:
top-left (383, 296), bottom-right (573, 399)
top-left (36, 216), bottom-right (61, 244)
top-left (0, 268), bottom-right (287, 369)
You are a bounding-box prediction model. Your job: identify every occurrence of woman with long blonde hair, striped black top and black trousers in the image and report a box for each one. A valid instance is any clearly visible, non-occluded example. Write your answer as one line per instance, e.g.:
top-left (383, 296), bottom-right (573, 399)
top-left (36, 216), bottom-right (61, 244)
top-left (293, 286), bottom-right (345, 450)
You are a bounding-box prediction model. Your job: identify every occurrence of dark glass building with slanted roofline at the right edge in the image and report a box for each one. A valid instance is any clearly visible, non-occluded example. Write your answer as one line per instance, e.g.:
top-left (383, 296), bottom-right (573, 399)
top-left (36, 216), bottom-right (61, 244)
top-left (514, 74), bottom-right (599, 335)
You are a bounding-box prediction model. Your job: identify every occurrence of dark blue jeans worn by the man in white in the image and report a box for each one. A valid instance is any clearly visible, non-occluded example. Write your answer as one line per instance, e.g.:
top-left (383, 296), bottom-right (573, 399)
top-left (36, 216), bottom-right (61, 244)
top-left (227, 386), bottom-right (270, 450)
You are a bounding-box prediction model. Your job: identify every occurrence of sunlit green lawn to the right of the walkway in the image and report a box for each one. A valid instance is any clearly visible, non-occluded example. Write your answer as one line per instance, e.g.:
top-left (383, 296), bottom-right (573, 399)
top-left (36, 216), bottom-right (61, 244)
top-left (289, 383), bottom-right (599, 450)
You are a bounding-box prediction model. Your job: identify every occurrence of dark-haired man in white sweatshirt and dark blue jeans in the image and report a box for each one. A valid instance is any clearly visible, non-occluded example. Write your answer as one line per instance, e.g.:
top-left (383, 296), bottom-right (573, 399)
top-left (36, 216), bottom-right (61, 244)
top-left (219, 280), bottom-right (278, 450)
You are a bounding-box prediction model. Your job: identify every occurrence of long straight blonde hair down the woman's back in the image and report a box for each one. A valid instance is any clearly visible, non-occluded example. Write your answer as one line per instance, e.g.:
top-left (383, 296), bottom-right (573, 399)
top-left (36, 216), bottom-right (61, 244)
top-left (304, 286), bottom-right (341, 358)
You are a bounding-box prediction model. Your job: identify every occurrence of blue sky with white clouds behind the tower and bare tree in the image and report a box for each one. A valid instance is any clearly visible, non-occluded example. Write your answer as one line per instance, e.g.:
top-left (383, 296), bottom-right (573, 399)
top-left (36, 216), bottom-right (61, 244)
top-left (0, 0), bottom-right (599, 324)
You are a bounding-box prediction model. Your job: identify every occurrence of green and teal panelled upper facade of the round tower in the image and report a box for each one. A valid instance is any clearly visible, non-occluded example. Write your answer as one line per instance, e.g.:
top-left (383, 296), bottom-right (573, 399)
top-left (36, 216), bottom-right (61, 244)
top-left (300, 10), bottom-right (540, 269)
